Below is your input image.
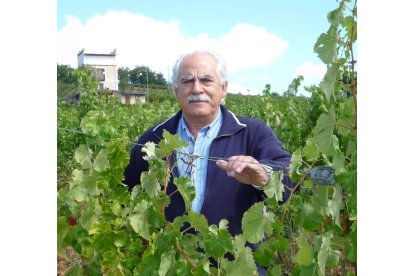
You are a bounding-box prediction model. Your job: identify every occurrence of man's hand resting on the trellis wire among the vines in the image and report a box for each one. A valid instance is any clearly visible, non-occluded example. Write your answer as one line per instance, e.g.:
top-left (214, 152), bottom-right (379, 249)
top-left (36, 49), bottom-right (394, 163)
top-left (216, 155), bottom-right (268, 187)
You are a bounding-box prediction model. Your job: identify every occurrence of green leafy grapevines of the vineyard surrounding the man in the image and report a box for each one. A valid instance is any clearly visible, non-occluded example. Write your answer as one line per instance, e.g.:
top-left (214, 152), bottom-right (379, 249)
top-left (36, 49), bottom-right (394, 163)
top-left (57, 1), bottom-right (357, 275)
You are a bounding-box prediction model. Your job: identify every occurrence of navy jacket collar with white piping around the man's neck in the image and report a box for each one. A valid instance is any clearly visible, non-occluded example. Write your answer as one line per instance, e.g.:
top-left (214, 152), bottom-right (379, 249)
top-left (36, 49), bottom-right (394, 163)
top-left (152, 105), bottom-right (246, 140)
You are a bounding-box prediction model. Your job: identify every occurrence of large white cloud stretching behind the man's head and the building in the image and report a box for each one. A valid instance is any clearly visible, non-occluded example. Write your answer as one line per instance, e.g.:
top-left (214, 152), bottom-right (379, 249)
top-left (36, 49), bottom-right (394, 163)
top-left (57, 11), bottom-right (288, 85)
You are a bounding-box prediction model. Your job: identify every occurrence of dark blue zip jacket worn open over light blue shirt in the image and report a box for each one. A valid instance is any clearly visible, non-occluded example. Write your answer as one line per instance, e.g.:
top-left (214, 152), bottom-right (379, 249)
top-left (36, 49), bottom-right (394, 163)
top-left (124, 106), bottom-right (293, 235)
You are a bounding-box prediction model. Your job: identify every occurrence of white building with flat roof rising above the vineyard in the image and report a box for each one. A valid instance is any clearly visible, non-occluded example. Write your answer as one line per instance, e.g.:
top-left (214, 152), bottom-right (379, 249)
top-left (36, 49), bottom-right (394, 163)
top-left (78, 49), bottom-right (118, 90)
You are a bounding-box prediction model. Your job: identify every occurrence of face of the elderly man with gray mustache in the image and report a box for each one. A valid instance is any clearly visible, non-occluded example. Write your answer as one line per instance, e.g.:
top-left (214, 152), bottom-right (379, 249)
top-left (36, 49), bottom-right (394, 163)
top-left (175, 53), bottom-right (227, 122)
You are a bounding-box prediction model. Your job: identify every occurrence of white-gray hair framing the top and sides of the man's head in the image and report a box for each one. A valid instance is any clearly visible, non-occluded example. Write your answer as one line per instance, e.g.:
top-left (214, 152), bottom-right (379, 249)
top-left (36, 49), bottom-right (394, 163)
top-left (171, 50), bottom-right (228, 90)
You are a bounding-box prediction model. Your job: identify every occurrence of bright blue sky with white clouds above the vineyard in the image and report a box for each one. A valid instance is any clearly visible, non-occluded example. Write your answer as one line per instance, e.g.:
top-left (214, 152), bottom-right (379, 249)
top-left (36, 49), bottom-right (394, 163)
top-left (57, 0), bottom-right (338, 95)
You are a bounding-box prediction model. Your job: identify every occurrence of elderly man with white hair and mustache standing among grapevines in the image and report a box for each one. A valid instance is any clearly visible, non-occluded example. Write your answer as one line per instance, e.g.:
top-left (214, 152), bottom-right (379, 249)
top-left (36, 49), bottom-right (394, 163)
top-left (125, 51), bottom-right (292, 235)
